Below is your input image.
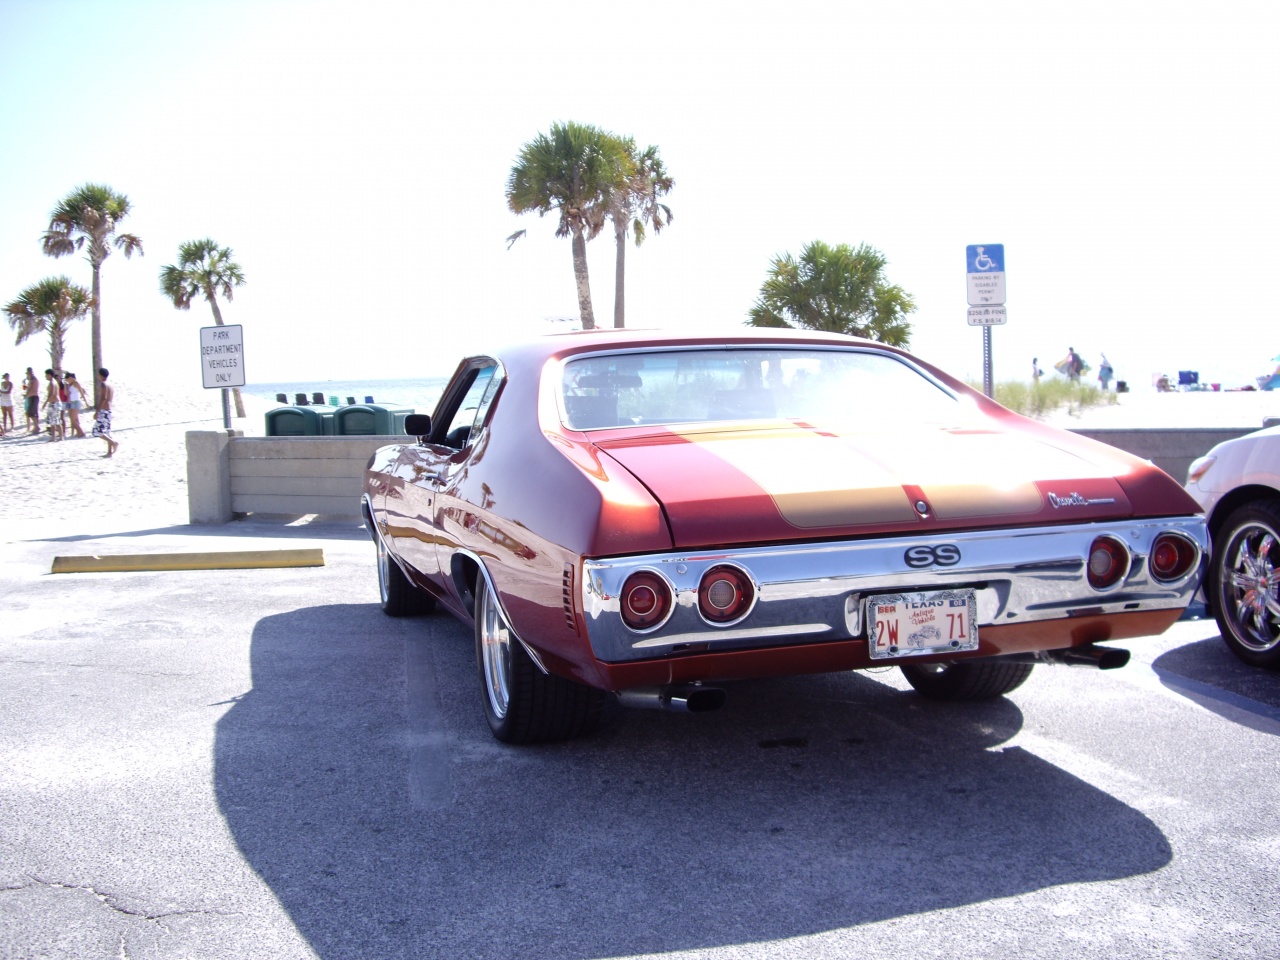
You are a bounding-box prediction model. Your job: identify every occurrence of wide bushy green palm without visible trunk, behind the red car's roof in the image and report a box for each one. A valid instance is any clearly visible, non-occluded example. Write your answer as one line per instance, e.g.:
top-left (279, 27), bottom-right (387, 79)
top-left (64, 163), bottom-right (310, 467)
top-left (746, 241), bottom-right (915, 347)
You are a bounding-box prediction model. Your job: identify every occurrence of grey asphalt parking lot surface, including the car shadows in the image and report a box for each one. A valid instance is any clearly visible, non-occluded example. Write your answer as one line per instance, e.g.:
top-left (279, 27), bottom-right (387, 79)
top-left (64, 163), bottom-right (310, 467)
top-left (0, 518), bottom-right (1280, 960)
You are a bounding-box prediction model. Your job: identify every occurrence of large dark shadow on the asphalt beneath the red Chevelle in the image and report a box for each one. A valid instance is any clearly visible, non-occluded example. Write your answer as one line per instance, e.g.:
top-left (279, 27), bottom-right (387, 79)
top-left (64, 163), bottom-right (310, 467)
top-left (215, 604), bottom-right (1171, 960)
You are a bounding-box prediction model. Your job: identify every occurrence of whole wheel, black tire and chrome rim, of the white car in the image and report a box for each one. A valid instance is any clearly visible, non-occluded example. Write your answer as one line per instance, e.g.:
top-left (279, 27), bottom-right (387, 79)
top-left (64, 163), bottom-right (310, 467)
top-left (1204, 500), bottom-right (1280, 669)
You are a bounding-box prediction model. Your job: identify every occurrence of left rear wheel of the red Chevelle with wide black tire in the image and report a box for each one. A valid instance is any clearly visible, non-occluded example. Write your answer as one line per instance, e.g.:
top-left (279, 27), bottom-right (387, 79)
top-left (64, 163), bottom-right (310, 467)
top-left (476, 576), bottom-right (605, 744)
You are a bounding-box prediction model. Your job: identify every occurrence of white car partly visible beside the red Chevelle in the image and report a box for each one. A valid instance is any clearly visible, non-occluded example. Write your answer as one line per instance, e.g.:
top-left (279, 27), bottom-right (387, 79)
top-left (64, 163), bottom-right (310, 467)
top-left (1187, 426), bottom-right (1280, 669)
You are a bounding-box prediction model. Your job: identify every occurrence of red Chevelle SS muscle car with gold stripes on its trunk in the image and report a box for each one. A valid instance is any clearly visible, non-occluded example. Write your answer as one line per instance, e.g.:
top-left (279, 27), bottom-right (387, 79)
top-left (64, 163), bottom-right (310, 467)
top-left (362, 330), bottom-right (1207, 742)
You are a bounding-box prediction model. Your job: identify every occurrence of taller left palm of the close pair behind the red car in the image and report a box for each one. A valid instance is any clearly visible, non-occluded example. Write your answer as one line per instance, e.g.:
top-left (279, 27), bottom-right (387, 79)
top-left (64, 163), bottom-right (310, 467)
top-left (507, 122), bottom-right (627, 330)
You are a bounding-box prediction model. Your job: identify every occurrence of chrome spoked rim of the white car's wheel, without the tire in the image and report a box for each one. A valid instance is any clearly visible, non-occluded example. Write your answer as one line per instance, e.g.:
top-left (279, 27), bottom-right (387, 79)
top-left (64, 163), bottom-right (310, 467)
top-left (1221, 524), bottom-right (1280, 653)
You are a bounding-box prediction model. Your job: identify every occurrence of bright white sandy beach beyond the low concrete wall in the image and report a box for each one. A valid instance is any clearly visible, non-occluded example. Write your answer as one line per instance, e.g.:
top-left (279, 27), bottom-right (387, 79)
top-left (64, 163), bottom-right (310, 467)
top-left (0, 381), bottom-right (1280, 541)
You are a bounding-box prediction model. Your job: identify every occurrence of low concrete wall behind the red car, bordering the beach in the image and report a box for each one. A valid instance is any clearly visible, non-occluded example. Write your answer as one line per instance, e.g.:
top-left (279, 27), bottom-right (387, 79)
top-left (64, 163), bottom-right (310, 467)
top-left (187, 428), bottom-right (1252, 524)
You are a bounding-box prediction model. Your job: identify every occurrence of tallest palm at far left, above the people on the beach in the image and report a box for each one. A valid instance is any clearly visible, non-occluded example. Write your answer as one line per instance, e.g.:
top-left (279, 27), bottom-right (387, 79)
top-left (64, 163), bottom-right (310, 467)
top-left (41, 183), bottom-right (142, 407)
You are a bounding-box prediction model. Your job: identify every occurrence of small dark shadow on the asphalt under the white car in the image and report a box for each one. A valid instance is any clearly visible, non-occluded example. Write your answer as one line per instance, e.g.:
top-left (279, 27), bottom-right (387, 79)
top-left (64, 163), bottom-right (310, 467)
top-left (1151, 636), bottom-right (1280, 736)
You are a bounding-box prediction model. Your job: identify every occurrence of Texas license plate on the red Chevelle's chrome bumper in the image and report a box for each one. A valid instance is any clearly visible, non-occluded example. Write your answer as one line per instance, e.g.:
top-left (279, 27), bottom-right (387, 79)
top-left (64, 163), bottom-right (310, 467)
top-left (867, 590), bottom-right (978, 659)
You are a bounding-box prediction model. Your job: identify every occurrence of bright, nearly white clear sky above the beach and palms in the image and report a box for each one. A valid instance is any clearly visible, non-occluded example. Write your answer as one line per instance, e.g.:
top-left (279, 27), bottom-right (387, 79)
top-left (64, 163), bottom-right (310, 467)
top-left (0, 0), bottom-right (1280, 387)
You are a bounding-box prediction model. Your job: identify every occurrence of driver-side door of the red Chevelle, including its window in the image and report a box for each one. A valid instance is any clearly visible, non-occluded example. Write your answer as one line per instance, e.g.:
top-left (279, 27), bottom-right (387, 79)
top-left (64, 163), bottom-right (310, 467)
top-left (388, 358), bottom-right (500, 614)
